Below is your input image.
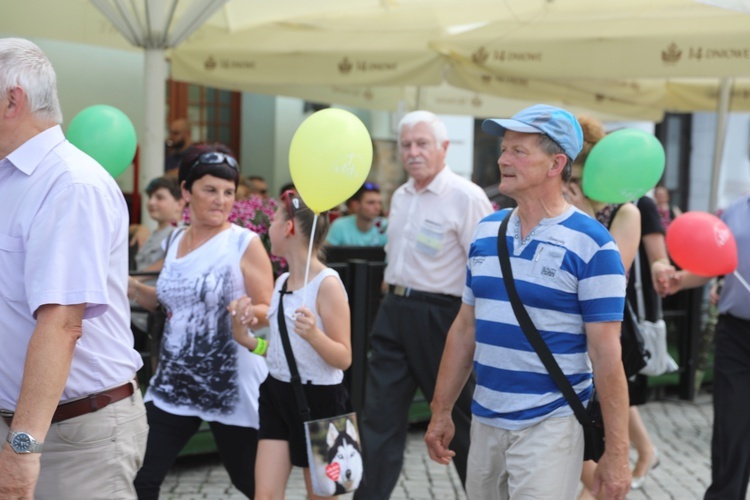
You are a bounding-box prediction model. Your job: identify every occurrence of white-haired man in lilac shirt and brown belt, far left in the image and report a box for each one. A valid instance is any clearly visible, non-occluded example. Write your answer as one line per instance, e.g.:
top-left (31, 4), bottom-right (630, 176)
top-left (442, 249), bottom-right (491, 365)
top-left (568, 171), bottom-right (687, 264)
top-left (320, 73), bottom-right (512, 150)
top-left (0, 38), bottom-right (148, 499)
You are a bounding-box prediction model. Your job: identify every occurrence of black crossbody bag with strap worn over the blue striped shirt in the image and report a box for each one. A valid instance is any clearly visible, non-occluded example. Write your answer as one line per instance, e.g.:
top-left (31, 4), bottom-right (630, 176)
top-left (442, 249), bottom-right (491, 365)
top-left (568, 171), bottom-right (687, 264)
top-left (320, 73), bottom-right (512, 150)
top-left (497, 211), bottom-right (604, 462)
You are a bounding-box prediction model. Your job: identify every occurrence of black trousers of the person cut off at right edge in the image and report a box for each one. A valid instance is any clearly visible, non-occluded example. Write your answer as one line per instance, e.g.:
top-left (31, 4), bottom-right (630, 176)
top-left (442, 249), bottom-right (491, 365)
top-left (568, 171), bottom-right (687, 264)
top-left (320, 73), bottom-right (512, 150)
top-left (705, 314), bottom-right (750, 500)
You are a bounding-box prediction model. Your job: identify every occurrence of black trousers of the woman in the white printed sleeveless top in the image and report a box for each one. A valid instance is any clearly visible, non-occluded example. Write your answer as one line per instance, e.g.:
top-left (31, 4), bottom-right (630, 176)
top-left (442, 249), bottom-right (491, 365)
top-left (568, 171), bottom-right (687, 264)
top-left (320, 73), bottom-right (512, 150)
top-left (134, 401), bottom-right (258, 500)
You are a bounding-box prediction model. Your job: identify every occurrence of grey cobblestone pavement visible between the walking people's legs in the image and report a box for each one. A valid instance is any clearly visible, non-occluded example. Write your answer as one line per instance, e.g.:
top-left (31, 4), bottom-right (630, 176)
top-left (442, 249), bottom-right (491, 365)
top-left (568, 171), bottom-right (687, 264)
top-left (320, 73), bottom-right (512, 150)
top-left (161, 395), bottom-right (736, 500)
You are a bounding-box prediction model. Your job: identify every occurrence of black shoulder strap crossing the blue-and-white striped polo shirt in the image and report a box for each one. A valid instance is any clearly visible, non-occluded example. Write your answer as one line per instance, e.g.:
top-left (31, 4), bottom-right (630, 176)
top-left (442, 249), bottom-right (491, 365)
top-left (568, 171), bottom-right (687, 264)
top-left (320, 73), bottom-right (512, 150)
top-left (497, 210), bottom-right (593, 425)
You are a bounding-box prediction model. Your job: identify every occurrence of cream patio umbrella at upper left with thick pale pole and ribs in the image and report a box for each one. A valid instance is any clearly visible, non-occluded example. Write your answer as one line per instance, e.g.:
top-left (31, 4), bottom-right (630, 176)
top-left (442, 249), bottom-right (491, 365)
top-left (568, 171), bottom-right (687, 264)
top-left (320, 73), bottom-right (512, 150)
top-left (0, 0), bottom-right (476, 215)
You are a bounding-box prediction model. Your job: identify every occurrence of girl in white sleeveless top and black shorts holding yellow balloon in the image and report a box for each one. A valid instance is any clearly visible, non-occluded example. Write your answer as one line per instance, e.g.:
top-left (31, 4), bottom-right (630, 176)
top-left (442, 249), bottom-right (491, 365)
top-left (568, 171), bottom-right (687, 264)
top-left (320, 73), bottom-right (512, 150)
top-left (230, 191), bottom-right (352, 499)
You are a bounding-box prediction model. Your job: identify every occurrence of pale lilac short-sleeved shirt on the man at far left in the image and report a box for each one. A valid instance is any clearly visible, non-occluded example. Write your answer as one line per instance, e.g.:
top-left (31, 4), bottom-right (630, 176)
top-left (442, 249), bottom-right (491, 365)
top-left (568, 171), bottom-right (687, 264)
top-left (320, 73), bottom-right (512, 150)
top-left (0, 126), bottom-right (143, 410)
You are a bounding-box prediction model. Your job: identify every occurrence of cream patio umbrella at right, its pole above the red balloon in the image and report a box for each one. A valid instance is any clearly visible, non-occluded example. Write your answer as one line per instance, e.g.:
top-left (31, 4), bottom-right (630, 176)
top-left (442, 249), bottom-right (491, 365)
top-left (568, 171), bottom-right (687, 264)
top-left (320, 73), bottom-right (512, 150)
top-left (433, 0), bottom-right (750, 209)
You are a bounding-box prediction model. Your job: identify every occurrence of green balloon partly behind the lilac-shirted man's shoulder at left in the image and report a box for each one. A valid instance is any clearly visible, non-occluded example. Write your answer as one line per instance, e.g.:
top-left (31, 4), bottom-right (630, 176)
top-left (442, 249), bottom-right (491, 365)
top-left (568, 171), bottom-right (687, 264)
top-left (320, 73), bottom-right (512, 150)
top-left (67, 104), bottom-right (138, 177)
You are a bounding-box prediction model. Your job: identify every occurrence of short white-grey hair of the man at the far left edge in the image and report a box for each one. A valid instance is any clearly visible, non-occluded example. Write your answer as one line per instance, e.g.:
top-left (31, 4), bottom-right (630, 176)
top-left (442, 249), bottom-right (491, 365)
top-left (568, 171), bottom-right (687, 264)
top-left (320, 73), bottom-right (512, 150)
top-left (0, 38), bottom-right (62, 124)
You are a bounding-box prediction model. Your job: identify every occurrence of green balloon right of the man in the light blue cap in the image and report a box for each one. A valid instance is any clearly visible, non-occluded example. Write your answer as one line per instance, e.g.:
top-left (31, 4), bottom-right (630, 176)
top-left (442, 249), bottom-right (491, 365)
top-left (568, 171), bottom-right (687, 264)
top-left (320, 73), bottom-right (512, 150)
top-left (582, 129), bottom-right (665, 203)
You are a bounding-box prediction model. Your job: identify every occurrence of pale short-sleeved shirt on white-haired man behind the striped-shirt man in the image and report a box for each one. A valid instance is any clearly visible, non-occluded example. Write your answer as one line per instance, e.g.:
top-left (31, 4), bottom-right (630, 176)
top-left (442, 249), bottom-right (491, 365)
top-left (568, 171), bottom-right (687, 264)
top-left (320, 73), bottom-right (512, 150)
top-left (385, 166), bottom-right (492, 297)
